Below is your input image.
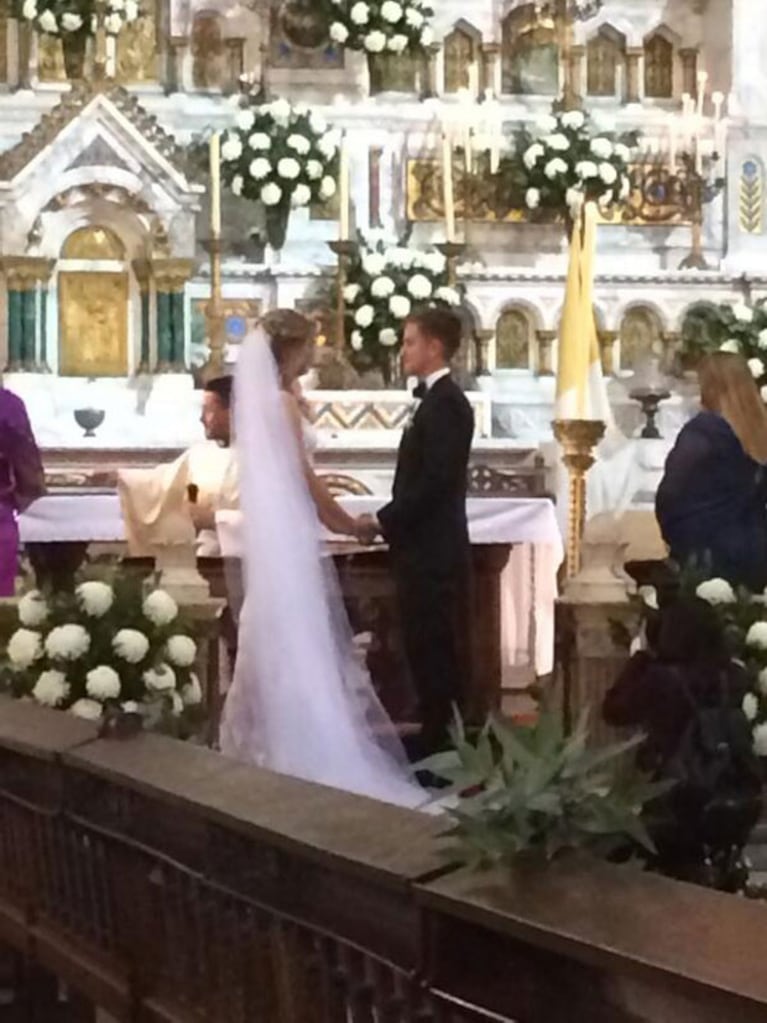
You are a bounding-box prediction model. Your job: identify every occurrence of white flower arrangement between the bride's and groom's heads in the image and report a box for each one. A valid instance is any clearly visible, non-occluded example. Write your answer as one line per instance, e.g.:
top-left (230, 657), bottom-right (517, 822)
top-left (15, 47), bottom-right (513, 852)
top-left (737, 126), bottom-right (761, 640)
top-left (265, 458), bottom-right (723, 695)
top-left (344, 240), bottom-right (462, 383)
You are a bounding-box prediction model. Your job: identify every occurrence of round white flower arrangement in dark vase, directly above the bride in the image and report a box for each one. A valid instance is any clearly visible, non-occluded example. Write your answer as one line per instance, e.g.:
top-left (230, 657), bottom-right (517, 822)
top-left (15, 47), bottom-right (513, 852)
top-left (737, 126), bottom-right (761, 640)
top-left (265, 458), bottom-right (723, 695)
top-left (221, 99), bottom-right (340, 249)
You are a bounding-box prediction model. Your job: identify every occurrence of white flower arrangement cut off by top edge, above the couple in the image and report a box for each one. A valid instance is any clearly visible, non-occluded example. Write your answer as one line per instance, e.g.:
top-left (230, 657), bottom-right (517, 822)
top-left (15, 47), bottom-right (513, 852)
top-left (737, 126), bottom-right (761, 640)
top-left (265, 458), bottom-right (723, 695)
top-left (326, 0), bottom-right (434, 55)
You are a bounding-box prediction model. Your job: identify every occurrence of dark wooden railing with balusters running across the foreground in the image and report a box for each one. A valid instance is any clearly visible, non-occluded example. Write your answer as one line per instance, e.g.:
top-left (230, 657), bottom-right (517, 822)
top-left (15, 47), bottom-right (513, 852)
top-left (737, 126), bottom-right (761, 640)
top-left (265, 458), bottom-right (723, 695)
top-left (0, 701), bottom-right (767, 1023)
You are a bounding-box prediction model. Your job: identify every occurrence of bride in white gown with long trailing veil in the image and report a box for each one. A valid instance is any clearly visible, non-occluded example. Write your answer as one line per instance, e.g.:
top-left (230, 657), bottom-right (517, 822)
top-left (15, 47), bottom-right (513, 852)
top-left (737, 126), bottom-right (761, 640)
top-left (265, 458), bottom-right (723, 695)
top-left (221, 310), bottom-right (427, 807)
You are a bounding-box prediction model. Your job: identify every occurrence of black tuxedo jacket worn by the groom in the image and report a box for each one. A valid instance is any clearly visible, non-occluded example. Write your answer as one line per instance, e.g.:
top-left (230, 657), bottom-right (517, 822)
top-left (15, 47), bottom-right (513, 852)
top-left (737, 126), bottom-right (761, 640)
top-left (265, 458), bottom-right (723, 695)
top-left (378, 376), bottom-right (475, 574)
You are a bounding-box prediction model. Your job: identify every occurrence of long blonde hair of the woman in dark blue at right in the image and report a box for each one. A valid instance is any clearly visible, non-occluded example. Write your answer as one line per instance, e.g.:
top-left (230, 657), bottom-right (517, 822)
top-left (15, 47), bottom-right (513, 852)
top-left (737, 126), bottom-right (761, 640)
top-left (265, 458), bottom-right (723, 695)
top-left (697, 352), bottom-right (767, 463)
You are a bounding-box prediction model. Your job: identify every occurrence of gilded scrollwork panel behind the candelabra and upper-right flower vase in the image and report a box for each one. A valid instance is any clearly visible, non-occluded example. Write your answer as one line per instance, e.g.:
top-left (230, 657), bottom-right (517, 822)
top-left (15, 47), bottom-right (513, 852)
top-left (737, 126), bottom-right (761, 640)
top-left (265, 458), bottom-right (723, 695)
top-left (407, 157), bottom-right (689, 226)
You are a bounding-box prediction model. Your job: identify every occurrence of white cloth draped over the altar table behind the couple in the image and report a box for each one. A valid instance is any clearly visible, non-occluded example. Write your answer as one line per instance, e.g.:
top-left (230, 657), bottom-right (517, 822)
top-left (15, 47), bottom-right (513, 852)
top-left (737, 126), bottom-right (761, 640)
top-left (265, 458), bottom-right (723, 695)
top-left (19, 492), bottom-right (563, 678)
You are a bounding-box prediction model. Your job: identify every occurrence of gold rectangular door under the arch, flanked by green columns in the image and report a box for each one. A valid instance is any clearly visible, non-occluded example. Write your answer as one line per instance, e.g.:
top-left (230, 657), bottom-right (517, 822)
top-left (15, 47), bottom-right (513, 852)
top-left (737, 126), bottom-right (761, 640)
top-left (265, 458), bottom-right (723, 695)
top-left (58, 272), bottom-right (129, 376)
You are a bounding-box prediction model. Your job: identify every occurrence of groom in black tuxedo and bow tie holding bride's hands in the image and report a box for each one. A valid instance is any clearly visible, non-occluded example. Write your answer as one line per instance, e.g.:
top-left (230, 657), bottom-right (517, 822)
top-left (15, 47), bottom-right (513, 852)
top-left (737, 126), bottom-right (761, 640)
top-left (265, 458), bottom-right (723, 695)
top-left (359, 309), bottom-right (473, 756)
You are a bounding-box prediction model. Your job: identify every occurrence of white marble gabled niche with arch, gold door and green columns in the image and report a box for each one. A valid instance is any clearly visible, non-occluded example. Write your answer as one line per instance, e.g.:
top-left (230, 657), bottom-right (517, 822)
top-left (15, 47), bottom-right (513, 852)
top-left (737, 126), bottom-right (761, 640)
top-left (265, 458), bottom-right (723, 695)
top-left (0, 81), bottom-right (202, 375)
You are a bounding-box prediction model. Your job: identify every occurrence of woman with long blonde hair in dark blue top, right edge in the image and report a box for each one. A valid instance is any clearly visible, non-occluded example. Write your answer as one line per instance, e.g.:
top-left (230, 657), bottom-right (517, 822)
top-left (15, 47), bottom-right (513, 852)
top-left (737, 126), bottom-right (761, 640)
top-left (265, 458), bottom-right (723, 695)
top-left (656, 352), bottom-right (767, 591)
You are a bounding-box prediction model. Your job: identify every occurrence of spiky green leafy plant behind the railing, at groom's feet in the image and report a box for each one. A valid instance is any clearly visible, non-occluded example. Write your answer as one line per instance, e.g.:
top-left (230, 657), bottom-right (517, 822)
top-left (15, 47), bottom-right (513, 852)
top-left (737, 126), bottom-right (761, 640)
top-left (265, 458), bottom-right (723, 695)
top-left (423, 711), bottom-right (669, 866)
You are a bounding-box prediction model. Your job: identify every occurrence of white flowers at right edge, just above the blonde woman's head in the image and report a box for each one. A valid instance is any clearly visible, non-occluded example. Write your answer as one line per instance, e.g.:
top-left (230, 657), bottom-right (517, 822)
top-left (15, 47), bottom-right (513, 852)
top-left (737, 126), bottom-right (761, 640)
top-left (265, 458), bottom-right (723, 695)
top-left (681, 301), bottom-right (767, 394)
